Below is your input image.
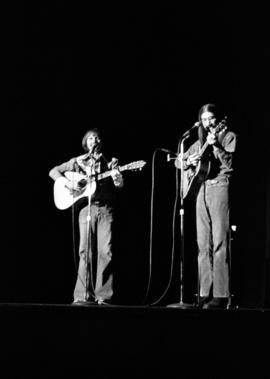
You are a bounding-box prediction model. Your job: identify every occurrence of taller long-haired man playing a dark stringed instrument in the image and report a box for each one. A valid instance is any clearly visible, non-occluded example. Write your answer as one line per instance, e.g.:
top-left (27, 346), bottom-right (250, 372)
top-left (175, 104), bottom-right (236, 308)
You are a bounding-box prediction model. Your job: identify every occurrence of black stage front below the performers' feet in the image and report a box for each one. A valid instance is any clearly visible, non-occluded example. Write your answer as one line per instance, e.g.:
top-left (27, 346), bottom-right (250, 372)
top-left (0, 303), bottom-right (270, 378)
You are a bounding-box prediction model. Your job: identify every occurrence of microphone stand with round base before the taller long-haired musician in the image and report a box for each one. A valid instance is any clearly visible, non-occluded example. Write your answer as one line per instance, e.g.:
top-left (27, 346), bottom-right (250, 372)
top-left (167, 133), bottom-right (194, 309)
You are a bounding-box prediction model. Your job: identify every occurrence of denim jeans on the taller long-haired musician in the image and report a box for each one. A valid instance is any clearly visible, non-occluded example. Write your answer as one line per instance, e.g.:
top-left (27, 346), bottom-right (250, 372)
top-left (196, 177), bottom-right (230, 297)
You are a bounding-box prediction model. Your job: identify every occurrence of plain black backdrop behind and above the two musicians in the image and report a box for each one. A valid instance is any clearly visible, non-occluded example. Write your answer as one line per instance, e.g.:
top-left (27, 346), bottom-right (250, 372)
top-left (3, 1), bottom-right (270, 307)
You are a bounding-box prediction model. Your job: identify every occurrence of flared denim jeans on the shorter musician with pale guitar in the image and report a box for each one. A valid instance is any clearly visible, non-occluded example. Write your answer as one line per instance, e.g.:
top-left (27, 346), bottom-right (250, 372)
top-left (73, 204), bottom-right (113, 300)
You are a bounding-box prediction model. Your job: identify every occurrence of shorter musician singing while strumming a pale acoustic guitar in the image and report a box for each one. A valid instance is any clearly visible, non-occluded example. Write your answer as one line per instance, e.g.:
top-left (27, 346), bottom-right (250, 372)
top-left (49, 128), bottom-right (124, 305)
